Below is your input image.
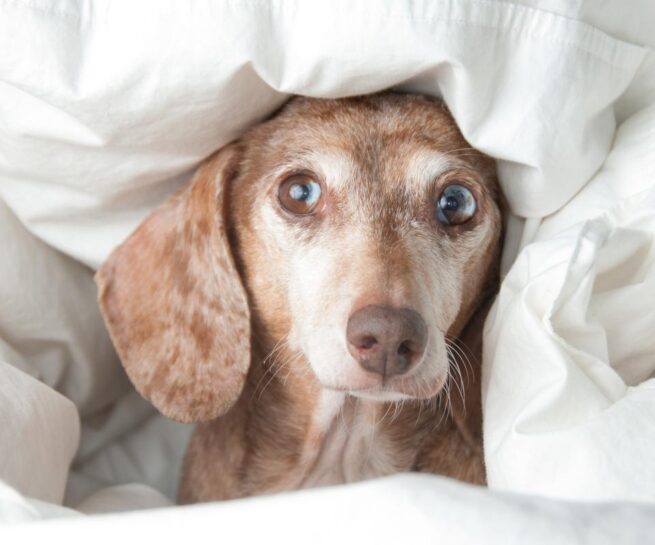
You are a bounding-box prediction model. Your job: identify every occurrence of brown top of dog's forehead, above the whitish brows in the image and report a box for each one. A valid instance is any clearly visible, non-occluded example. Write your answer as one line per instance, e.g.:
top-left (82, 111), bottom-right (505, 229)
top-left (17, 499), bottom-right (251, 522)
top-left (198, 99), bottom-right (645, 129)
top-left (262, 94), bottom-right (468, 174)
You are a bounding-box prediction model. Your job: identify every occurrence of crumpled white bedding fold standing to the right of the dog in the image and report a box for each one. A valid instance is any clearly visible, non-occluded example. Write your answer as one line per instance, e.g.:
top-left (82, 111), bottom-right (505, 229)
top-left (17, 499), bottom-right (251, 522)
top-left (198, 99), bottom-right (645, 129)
top-left (483, 105), bottom-right (655, 501)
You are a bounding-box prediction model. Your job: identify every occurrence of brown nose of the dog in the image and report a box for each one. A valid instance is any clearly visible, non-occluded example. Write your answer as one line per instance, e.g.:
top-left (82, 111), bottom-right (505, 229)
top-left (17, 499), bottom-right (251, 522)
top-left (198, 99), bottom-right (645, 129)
top-left (346, 305), bottom-right (428, 377)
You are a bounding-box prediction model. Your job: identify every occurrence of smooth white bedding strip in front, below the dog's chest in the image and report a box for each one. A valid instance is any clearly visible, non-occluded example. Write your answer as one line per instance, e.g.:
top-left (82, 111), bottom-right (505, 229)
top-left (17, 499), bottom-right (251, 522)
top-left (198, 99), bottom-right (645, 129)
top-left (0, 474), bottom-right (655, 545)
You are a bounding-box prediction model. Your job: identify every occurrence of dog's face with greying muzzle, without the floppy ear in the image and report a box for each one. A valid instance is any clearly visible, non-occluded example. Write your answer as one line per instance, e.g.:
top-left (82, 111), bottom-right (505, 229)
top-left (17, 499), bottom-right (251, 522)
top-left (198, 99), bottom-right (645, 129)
top-left (230, 95), bottom-right (502, 400)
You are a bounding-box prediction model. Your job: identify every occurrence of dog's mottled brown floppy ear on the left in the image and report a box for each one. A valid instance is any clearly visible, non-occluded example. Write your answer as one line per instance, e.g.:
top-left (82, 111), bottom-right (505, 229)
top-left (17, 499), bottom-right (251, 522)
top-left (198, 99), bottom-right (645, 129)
top-left (96, 145), bottom-right (250, 422)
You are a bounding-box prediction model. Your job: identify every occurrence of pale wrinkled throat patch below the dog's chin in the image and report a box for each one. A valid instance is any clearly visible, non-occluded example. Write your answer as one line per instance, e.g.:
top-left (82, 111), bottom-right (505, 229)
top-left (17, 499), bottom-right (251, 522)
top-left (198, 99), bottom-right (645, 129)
top-left (298, 391), bottom-right (414, 488)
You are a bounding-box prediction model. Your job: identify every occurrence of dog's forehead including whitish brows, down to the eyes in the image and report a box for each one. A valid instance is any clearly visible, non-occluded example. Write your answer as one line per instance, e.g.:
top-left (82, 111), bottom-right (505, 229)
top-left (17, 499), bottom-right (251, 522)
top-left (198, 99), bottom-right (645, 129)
top-left (238, 93), bottom-right (494, 208)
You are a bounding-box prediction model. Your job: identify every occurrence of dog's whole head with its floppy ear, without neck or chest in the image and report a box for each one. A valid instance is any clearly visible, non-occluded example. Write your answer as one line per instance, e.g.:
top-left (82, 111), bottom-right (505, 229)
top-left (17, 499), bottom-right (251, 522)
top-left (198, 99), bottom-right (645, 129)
top-left (97, 93), bottom-right (502, 421)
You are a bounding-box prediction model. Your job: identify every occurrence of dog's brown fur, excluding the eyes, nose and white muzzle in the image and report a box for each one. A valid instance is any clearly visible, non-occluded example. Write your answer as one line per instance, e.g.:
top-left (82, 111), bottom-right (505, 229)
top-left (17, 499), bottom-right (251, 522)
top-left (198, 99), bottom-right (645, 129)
top-left (97, 93), bottom-right (502, 502)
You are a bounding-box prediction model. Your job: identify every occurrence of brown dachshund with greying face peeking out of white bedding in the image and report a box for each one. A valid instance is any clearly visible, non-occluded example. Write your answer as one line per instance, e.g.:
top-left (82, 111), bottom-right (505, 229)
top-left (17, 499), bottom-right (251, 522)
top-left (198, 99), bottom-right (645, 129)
top-left (96, 92), bottom-right (504, 503)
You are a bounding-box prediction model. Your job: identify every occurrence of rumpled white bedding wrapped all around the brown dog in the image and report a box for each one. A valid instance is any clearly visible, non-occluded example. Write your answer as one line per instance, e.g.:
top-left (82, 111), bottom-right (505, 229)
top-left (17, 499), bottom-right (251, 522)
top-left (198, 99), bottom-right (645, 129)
top-left (0, 0), bottom-right (655, 543)
